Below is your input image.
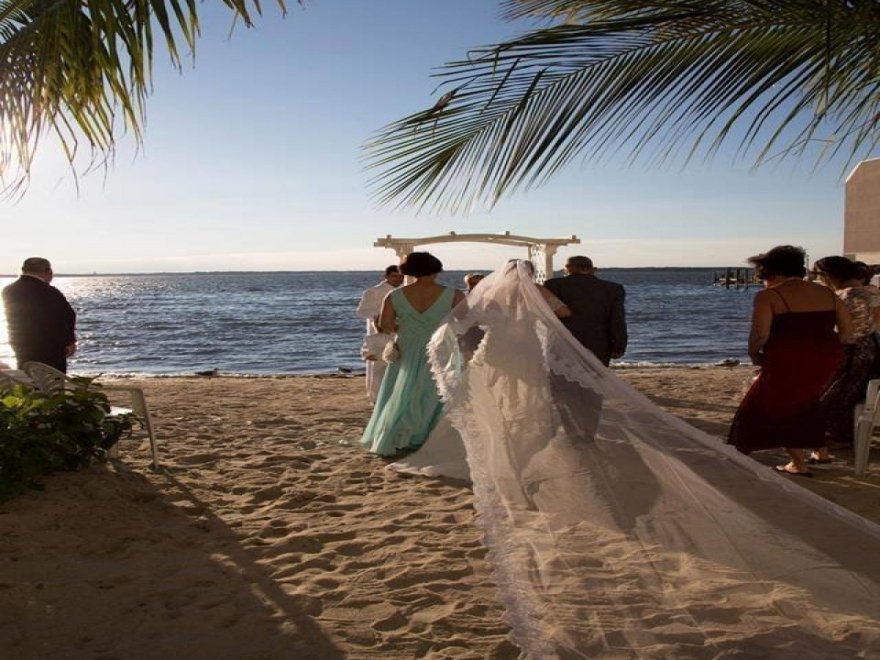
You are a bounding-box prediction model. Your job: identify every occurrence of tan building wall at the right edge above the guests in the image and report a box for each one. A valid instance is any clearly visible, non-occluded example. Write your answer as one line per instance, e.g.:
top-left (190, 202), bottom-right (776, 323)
top-left (843, 158), bottom-right (880, 263)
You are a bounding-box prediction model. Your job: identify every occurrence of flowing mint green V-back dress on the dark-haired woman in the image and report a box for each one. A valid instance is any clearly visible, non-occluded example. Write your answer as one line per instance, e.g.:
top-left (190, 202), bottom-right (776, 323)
top-left (361, 287), bottom-right (455, 456)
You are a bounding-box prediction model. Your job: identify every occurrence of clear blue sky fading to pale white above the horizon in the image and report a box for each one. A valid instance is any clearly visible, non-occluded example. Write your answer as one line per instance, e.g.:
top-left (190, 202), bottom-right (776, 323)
top-left (0, 0), bottom-right (868, 274)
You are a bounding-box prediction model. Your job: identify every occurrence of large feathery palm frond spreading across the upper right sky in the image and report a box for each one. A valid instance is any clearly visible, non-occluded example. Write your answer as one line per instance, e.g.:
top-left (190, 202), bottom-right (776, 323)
top-left (367, 0), bottom-right (880, 211)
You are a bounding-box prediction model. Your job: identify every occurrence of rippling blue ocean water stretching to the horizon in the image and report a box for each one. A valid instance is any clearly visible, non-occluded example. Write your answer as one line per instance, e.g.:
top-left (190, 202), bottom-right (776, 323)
top-left (0, 268), bottom-right (757, 375)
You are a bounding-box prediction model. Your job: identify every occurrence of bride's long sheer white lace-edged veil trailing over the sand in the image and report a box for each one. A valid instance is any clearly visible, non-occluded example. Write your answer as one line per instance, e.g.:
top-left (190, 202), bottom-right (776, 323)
top-left (428, 262), bottom-right (880, 660)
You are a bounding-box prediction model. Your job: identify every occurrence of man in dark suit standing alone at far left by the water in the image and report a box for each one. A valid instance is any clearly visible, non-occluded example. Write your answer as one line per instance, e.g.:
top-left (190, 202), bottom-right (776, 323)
top-left (3, 257), bottom-right (76, 372)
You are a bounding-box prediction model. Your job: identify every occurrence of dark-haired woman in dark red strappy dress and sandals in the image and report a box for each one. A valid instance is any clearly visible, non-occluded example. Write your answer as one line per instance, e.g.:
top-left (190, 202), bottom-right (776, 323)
top-left (728, 245), bottom-right (850, 476)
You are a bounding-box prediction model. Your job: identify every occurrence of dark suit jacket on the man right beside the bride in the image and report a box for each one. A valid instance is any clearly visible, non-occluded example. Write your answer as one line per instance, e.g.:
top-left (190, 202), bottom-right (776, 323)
top-left (544, 273), bottom-right (627, 365)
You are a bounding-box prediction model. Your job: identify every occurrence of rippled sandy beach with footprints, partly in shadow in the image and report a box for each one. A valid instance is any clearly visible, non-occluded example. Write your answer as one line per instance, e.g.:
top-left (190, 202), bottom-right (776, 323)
top-left (0, 367), bottom-right (880, 660)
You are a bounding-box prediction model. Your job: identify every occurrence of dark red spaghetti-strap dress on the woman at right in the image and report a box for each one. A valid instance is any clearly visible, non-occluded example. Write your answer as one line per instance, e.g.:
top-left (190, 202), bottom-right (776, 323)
top-left (727, 289), bottom-right (844, 454)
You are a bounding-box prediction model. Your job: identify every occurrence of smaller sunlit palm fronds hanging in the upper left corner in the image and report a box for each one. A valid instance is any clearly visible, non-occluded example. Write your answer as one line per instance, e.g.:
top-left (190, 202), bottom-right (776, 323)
top-left (0, 0), bottom-right (285, 193)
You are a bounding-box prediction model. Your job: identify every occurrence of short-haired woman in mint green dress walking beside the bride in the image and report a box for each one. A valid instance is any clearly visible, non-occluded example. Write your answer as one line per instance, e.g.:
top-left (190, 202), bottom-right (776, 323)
top-left (361, 252), bottom-right (464, 456)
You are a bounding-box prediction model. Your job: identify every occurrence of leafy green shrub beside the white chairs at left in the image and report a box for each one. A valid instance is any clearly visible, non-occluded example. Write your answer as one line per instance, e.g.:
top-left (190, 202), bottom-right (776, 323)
top-left (0, 378), bottom-right (137, 501)
